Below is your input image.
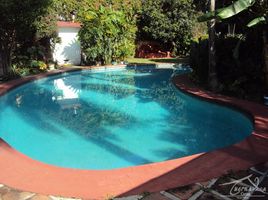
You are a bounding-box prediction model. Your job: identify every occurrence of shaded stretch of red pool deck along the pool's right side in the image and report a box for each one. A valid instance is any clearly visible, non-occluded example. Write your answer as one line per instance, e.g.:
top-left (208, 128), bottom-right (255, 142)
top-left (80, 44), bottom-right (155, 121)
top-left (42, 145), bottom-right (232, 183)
top-left (116, 74), bottom-right (268, 196)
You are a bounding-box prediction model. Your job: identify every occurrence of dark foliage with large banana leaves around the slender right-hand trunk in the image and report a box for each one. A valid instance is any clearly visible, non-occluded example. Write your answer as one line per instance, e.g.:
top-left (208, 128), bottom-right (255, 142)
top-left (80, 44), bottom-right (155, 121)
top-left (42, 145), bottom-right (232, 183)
top-left (191, 0), bottom-right (268, 101)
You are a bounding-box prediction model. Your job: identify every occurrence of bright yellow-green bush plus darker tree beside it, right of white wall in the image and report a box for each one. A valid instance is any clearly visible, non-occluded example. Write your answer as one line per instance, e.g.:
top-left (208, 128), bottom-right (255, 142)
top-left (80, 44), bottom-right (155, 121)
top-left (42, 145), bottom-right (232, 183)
top-left (79, 0), bottom-right (200, 64)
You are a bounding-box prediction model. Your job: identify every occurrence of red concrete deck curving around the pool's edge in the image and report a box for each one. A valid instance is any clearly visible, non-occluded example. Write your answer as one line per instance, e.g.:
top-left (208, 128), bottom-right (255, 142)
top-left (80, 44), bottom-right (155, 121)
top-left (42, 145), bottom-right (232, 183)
top-left (0, 69), bottom-right (268, 199)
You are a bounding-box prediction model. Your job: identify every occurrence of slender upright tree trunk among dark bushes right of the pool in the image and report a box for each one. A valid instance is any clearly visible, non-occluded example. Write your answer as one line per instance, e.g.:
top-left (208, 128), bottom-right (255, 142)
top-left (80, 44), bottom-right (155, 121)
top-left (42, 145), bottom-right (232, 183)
top-left (208, 0), bottom-right (218, 91)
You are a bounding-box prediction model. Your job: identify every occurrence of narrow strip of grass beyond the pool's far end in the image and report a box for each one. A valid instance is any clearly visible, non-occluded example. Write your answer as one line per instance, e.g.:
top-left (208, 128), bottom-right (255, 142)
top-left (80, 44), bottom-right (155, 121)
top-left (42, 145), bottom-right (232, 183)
top-left (126, 57), bottom-right (188, 64)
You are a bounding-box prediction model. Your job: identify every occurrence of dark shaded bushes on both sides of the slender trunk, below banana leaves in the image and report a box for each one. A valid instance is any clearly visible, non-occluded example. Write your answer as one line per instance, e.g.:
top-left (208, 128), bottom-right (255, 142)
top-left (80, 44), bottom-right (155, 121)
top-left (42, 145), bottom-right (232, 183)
top-left (190, 32), bottom-right (264, 101)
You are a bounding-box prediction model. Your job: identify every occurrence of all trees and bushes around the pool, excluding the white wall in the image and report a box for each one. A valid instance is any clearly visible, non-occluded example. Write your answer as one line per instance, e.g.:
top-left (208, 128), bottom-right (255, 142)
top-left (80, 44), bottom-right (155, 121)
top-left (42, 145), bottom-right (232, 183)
top-left (0, 0), bottom-right (268, 101)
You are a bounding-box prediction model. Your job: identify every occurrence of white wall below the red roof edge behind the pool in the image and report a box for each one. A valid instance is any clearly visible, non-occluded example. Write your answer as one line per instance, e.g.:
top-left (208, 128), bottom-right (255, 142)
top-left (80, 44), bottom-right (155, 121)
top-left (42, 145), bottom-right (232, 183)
top-left (53, 27), bottom-right (81, 65)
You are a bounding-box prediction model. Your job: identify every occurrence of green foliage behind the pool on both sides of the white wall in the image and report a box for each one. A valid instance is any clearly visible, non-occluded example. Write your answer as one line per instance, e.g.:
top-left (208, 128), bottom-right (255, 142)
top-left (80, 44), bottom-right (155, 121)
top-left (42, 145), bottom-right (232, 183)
top-left (0, 0), bottom-right (202, 74)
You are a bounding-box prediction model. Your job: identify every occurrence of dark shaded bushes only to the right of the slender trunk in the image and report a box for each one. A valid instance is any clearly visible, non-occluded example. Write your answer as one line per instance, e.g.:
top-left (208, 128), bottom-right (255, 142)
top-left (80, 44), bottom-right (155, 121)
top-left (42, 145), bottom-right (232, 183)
top-left (216, 32), bottom-right (265, 101)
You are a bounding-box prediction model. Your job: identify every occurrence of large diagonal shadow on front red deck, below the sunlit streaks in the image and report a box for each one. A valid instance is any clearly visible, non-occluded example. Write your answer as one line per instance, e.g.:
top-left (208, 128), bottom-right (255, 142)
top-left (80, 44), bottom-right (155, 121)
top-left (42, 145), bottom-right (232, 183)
top-left (118, 134), bottom-right (268, 197)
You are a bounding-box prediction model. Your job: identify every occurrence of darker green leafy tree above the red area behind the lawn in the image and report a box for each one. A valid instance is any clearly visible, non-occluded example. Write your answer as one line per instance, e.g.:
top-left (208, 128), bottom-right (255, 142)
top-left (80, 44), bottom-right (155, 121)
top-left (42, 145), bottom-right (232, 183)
top-left (139, 0), bottom-right (195, 54)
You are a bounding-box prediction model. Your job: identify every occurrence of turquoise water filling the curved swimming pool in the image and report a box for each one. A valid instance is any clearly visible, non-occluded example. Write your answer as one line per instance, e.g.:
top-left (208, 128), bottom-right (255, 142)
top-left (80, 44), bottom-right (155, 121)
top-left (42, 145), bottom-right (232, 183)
top-left (0, 67), bottom-right (253, 170)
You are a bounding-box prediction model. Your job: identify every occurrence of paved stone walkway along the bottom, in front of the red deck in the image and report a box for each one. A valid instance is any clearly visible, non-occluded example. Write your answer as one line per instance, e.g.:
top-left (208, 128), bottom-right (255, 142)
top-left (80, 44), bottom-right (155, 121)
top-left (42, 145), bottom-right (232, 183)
top-left (0, 162), bottom-right (268, 200)
